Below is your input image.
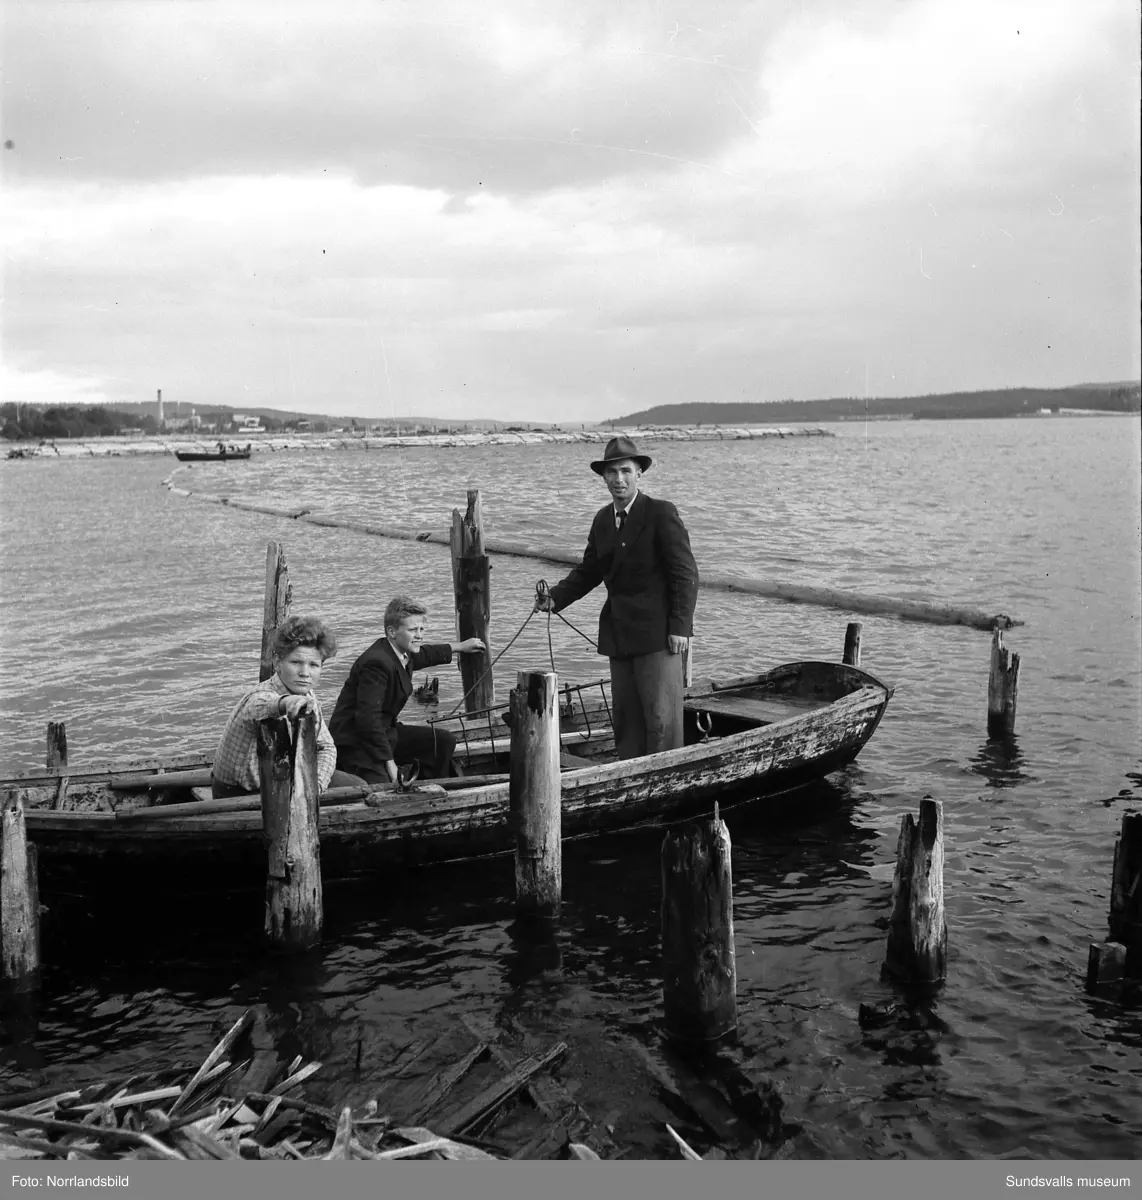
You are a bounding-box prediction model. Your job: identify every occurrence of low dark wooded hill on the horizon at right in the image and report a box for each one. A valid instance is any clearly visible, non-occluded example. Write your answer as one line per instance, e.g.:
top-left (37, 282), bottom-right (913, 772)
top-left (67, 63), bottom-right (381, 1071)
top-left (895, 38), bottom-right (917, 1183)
top-left (607, 383), bottom-right (1142, 425)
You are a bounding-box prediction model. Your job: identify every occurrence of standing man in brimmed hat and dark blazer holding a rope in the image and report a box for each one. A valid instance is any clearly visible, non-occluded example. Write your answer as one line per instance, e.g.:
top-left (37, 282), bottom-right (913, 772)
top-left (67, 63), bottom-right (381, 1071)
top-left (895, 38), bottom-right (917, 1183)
top-left (535, 436), bottom-right (698, 758)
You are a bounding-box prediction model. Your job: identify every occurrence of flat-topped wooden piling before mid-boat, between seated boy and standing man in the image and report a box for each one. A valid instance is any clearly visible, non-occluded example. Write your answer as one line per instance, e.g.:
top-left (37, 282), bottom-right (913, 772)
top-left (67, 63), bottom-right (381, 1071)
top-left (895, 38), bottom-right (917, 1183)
top-left (509, 671), bottom-right (563, 917)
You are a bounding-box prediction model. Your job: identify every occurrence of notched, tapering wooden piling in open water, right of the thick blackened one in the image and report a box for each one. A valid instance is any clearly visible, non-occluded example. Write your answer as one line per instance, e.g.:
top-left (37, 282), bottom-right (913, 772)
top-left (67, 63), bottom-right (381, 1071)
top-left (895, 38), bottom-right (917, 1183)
top-left (884, 796), bottom-right (948, 984)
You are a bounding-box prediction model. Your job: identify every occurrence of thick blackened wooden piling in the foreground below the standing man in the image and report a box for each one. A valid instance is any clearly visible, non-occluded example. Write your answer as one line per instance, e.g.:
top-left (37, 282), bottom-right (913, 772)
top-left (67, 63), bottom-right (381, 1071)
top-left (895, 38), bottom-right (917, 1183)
top-left (662, 812), bottom-right (738, 1043)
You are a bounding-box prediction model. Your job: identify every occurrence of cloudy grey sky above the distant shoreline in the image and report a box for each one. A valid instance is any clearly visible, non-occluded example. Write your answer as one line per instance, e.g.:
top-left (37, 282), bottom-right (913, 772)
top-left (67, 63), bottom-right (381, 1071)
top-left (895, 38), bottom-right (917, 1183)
top-left (0, 0), bottom-right (1142, 424)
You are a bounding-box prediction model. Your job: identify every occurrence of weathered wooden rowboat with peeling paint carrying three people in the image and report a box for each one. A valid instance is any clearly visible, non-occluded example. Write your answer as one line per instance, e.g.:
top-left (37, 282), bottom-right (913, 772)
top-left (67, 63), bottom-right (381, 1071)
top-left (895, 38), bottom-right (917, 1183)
top-left (0, 662), bottom-right (892, 875)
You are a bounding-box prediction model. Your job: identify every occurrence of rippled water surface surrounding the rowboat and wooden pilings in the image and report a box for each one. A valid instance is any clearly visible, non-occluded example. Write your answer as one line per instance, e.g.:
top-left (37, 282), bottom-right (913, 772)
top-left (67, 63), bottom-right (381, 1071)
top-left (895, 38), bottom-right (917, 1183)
top-left (0, 418), bottom-right (1142, 1158)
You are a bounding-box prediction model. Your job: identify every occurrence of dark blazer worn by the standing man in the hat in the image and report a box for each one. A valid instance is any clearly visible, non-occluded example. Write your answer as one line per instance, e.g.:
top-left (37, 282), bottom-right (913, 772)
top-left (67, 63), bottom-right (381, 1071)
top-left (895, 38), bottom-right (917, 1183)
top-left (551, 491), bottom-right (698, 659)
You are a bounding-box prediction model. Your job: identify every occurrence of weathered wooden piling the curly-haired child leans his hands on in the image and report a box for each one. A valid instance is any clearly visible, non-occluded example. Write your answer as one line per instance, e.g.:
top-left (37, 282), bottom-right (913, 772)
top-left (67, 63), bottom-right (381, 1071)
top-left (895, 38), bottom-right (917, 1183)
top-left (258, 712), bottom-right (323, 950)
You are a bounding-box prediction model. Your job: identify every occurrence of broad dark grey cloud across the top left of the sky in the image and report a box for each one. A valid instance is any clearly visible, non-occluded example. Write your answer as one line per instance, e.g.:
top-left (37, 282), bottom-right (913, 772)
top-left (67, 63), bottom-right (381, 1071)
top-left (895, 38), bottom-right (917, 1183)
top-left (5, 0), bottom-right (777, 192)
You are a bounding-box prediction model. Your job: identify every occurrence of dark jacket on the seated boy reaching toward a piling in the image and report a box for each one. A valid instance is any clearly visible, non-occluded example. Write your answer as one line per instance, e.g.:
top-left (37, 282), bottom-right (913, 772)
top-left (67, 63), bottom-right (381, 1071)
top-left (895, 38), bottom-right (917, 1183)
top-left (329, 637), bottom-right (452, 770)
